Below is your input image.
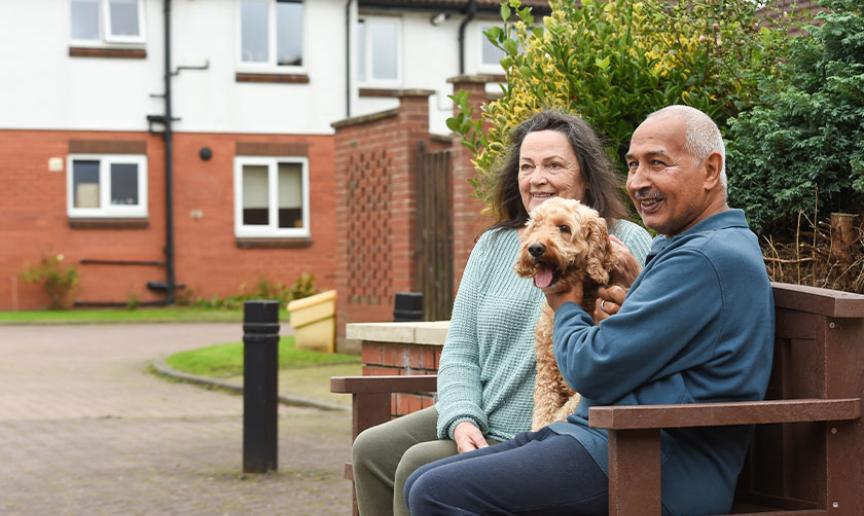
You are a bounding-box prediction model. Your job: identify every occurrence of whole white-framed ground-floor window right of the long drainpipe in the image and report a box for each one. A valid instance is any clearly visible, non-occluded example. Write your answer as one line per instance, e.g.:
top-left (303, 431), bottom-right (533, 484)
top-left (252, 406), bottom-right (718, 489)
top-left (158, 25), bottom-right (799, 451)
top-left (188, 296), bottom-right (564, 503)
top-left (234, 157), bottom-right (309, 238)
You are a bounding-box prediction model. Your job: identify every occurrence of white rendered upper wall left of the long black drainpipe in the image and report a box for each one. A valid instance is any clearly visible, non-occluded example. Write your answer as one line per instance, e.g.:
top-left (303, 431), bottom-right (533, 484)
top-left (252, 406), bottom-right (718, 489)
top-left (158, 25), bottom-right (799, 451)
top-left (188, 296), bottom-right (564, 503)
top-left (0, 0), bottom-right (162, 130)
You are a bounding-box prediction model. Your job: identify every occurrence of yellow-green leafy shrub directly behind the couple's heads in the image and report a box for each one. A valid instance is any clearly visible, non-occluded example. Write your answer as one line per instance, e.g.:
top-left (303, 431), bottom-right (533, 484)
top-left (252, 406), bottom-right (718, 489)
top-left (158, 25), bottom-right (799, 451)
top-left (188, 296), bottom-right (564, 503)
top-left (448, 0), bottom-right (786, 211)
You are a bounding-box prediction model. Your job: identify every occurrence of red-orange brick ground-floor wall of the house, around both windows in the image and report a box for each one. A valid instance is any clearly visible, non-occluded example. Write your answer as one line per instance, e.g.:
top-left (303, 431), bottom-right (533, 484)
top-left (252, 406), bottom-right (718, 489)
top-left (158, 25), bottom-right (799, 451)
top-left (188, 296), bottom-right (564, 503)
top-left (0, 131), bottom-right (335, 310)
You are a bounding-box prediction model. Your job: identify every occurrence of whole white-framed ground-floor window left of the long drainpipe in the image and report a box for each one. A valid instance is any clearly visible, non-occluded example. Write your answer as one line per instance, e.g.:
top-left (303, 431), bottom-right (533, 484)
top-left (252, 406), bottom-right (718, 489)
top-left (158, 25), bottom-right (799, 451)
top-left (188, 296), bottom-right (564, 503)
top-left (67, 154), bottom-right (147, 218)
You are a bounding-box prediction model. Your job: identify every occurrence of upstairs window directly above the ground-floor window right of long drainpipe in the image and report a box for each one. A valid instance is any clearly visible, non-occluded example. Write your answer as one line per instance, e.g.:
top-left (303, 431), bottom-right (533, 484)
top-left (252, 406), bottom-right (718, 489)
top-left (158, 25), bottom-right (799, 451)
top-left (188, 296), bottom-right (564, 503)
top-left (240, 0), bottom-right (303, 67)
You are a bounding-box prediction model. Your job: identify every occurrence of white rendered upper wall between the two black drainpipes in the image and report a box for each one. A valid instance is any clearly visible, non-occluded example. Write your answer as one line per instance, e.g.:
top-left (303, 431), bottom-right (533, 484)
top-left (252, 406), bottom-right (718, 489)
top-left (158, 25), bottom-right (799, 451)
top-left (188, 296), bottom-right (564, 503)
top-left (174, 0), bottom-right (346, 134)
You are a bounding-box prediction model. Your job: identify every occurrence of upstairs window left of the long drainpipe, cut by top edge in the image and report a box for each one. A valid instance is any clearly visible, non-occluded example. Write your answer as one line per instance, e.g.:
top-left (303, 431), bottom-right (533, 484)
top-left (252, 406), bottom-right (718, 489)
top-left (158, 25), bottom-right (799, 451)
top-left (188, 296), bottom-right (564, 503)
top-left (70, 0), bottom-right (145, 45)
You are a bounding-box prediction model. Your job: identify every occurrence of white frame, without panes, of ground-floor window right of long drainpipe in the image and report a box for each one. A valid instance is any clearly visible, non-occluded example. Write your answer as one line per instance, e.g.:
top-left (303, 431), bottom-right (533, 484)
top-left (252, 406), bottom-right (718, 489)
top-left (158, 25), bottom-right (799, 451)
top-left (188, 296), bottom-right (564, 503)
top-left (234, 156), bottom-right (311, 238)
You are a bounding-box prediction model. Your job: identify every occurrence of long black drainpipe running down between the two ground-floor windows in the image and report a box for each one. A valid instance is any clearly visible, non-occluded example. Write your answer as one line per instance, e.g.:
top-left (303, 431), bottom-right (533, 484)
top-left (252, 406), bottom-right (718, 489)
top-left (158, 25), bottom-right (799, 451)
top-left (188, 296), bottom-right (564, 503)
top-left (163, 0), bottom-right (176, 305)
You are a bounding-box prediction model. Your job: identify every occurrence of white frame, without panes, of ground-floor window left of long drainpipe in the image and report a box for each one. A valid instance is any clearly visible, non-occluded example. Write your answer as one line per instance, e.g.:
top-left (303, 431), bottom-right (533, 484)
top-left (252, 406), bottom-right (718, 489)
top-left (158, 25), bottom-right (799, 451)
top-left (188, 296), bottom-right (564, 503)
top-left (66, 154), bottom-right (148, 219)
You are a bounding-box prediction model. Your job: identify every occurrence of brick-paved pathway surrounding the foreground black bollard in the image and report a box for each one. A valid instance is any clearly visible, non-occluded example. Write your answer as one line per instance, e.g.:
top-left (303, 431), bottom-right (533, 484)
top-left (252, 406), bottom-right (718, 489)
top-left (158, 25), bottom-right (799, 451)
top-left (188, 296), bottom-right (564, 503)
top-left (0, 324), bottom-right (350, 515)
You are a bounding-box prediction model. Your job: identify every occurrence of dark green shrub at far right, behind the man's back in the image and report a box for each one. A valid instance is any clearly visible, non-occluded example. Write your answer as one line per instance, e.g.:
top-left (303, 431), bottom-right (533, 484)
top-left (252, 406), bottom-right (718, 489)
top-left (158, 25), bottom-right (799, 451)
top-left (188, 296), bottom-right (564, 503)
top-left (729, 0), bottom-right (864, 234)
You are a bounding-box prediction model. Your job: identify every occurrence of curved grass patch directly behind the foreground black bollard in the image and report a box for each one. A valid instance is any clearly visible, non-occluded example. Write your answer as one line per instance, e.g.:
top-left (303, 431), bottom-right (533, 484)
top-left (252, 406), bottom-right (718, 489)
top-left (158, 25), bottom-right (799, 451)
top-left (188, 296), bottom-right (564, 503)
top-left (165, 337), bottom-right (360, 378)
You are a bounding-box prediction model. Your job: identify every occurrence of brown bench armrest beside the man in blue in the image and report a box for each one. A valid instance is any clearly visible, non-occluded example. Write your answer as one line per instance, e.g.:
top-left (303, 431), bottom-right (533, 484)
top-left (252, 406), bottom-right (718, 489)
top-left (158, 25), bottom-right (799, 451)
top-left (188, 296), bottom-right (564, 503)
top-left (588, 398), bottom-right (861, 430)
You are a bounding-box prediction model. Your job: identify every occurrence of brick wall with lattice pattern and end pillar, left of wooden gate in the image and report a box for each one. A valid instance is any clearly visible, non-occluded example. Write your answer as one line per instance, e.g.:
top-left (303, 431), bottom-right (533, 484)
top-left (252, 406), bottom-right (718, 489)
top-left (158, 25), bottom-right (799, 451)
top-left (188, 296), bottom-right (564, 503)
top-left (332, 90), bottom-right (433, 337)
